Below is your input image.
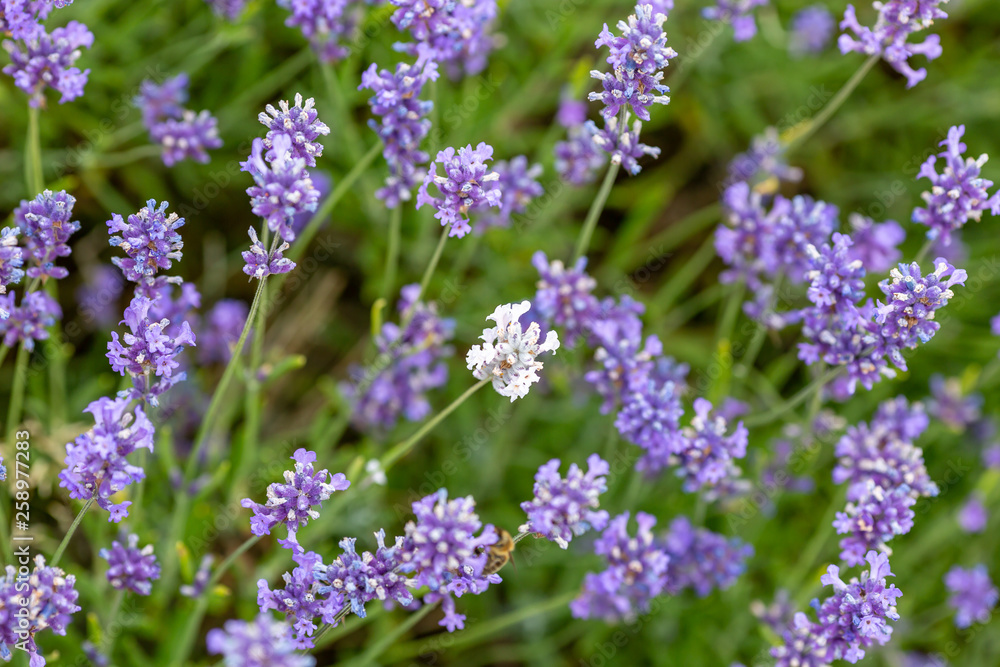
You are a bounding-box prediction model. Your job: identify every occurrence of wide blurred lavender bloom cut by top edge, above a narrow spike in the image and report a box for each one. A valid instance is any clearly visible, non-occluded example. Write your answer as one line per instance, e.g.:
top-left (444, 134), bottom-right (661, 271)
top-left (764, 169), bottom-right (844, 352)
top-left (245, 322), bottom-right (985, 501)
top-left (389, 0), bottom-right (497, 78)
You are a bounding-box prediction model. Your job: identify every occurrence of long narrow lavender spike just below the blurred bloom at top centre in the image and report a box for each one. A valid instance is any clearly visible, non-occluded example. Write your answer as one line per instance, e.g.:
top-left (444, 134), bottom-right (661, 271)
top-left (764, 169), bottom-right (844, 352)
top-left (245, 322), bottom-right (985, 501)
top-left (358, 60), bottom-right (438, 208)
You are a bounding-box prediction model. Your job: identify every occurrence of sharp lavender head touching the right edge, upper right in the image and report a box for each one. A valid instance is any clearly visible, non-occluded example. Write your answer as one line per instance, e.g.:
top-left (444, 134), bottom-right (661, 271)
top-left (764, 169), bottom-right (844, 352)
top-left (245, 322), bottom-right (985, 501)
top-left (913, 125), bottom-right (1000, 246)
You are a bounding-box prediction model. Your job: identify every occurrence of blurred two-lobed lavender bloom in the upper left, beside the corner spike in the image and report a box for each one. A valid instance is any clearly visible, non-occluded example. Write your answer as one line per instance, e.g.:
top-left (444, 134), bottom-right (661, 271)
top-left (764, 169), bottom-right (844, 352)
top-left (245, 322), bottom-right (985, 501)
top-left (135, 72), bottom-right (222, 167)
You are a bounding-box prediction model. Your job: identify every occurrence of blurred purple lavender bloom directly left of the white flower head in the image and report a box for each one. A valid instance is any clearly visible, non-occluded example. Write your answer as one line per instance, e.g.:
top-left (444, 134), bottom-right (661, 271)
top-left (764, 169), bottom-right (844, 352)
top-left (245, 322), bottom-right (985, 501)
top-left (341, 285), bottom-right (455, 431)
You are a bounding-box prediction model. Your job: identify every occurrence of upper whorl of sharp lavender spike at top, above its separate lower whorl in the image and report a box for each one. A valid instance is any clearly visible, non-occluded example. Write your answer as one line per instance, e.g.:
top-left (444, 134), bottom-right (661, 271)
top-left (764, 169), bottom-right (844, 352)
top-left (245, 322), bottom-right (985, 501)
top-left (590, 4), bottom-right (677, 122)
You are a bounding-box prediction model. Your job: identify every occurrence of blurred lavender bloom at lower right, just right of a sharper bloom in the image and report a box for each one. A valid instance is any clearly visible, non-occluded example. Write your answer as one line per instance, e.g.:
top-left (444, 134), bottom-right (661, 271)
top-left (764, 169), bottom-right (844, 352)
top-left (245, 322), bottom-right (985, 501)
top-left (661, 516), bottom-right (753, 597)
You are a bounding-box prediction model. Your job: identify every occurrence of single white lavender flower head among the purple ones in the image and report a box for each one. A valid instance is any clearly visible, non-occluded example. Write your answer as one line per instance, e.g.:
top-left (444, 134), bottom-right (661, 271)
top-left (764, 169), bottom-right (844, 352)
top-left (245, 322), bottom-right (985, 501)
top-left (465, 301), bottom-right (559, 403)
